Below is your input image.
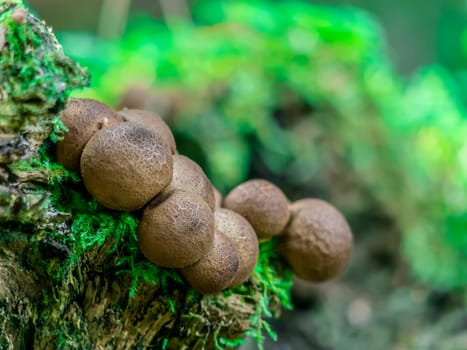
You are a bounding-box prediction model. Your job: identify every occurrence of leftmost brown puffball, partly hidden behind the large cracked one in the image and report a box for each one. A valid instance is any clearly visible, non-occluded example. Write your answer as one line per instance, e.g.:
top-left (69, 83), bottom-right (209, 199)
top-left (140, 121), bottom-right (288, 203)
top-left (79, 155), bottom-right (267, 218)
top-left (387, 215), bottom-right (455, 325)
top-left (56, 98), bottom-right (123, 171)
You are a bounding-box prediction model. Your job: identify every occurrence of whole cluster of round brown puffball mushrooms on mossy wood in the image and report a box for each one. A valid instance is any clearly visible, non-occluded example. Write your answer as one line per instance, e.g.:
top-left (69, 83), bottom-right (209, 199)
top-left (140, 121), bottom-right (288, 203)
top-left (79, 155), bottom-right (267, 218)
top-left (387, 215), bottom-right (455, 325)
top-left (56, 99), bottom-right (352, 294)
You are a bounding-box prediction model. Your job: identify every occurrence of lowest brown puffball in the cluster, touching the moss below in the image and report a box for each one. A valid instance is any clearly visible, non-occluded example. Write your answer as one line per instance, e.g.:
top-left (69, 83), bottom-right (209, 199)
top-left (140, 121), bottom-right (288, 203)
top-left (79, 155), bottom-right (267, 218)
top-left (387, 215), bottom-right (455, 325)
top-left (180, 232), bottom-right (238, 294)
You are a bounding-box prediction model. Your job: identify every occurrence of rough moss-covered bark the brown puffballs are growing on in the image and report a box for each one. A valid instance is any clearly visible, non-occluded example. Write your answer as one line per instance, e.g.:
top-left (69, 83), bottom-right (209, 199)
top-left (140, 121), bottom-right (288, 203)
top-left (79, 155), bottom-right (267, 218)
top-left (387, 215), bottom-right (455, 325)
top-left (0, 0), bottom-right (287, 349)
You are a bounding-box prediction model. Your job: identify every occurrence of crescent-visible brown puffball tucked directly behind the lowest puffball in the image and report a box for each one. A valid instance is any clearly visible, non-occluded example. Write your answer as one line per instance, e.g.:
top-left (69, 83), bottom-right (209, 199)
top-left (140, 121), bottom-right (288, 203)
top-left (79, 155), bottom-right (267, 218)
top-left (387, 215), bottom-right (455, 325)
top-left (214, 209), bottom-right (259, 287)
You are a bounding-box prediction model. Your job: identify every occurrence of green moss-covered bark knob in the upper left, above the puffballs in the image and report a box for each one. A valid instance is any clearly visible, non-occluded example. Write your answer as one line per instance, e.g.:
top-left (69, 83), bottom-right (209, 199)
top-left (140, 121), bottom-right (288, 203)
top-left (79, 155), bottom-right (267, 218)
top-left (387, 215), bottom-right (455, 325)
top-left (0, 1), bottom-right (89, 124)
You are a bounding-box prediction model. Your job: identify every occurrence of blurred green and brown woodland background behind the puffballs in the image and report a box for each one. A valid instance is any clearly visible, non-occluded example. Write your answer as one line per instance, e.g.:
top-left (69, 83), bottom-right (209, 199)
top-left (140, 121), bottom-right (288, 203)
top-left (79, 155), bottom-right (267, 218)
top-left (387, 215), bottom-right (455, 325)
top-left (28, 0), bottom-right (467, 350)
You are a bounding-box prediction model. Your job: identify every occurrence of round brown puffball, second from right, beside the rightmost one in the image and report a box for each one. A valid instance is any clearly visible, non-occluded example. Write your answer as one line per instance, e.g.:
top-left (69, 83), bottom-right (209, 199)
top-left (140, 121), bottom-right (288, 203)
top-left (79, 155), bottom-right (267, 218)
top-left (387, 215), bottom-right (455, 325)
top-left (224, 180), bottom-right (290, 239)
